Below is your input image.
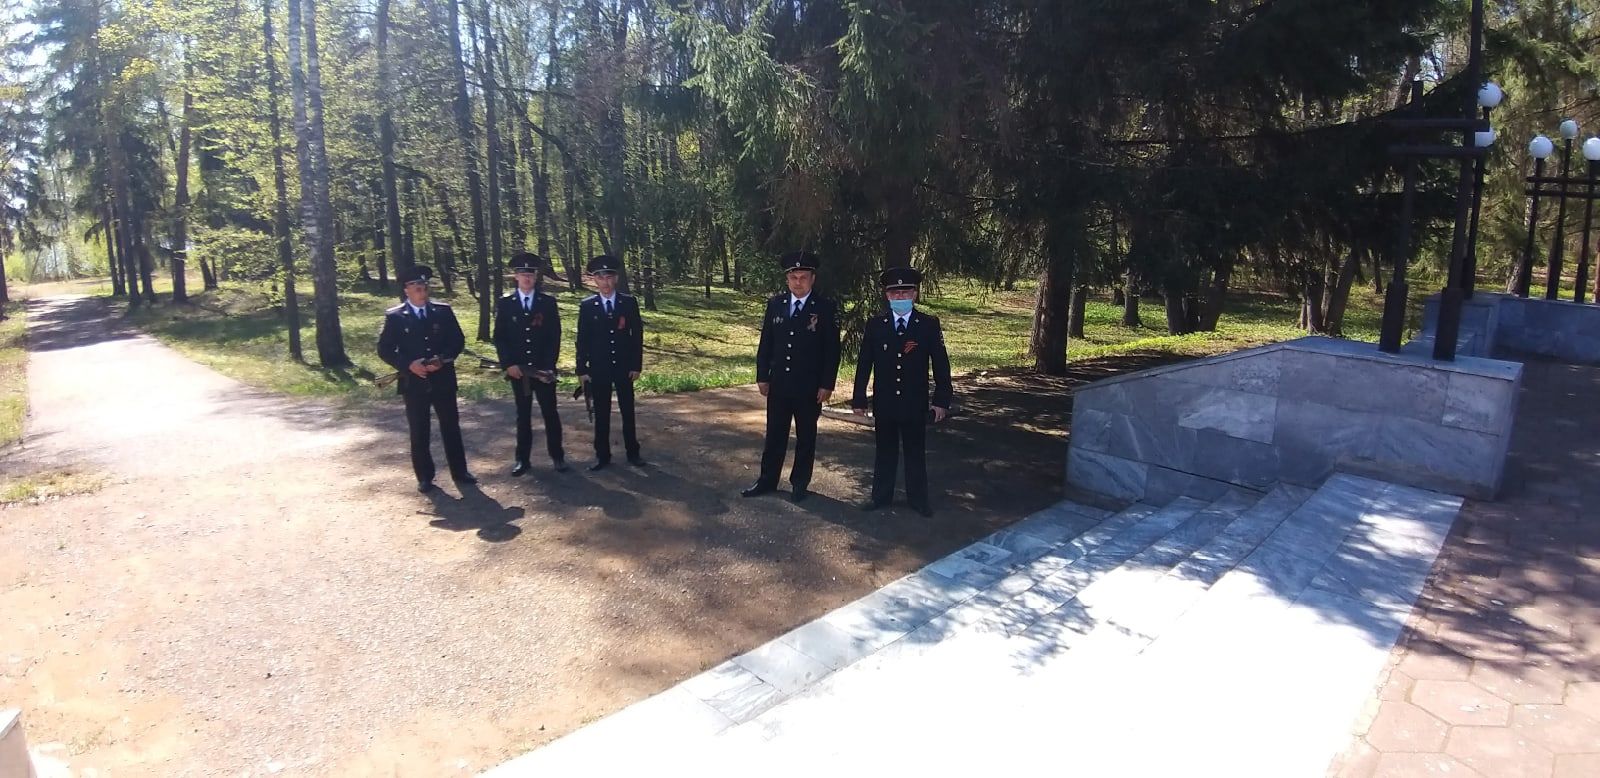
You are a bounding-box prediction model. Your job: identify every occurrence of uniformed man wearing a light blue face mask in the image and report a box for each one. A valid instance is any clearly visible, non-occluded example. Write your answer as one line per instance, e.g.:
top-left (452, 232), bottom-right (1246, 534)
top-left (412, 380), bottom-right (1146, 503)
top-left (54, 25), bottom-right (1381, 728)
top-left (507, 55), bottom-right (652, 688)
top-left (850, 267), bottom-right (952, 515)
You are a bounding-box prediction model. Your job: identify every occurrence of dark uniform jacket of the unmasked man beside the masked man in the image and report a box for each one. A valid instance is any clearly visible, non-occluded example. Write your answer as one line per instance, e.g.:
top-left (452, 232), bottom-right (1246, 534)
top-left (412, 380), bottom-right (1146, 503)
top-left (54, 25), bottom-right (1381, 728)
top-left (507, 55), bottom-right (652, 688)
top-left (755, 291), bottom-right (838, 397)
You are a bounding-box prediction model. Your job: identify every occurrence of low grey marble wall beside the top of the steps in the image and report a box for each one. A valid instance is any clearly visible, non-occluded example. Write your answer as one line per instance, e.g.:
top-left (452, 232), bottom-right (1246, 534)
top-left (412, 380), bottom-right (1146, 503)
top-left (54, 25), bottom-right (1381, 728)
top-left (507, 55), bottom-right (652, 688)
top-left (1067, 338), bottom-right (1522, 501)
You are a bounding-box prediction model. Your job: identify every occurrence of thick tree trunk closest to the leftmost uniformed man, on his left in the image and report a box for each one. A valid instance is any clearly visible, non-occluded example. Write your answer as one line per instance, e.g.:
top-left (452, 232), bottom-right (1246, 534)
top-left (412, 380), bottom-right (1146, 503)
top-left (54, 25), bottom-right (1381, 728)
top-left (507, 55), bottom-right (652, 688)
top-left (288, 0), bottom-right (350, 368)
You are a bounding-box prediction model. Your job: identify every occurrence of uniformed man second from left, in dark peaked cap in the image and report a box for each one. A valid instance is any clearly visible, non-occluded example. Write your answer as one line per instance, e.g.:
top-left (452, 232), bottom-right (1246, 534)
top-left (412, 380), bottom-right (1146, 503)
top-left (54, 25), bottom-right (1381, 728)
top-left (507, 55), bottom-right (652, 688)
top-left (494, 251), bottom-right (566, 475)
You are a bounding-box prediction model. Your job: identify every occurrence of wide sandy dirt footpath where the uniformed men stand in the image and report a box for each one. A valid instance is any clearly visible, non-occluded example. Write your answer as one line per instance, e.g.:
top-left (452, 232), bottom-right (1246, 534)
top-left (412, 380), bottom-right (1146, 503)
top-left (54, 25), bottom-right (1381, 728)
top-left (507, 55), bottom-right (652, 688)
top-left (0, 298), bottom-right (1113, 776)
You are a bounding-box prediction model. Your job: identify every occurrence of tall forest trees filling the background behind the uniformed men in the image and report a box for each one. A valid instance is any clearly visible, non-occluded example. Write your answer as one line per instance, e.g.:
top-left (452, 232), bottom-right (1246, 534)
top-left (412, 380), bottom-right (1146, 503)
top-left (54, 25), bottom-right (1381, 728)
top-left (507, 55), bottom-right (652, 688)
top-left (0, 0), bottom-right (1600, 373)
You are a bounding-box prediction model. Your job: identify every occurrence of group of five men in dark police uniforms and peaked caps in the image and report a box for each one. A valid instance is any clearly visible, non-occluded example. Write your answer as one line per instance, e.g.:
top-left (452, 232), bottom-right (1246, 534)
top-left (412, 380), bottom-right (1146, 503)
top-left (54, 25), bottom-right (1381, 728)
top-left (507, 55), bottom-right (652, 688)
top-left (378, 251), bottom-right (952, 515)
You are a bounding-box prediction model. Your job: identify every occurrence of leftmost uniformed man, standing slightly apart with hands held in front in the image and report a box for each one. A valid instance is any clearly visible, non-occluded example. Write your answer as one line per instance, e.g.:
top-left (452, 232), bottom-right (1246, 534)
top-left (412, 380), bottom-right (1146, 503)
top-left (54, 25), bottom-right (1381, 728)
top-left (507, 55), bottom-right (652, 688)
top-left (378, 264), bottom-right (478, 493)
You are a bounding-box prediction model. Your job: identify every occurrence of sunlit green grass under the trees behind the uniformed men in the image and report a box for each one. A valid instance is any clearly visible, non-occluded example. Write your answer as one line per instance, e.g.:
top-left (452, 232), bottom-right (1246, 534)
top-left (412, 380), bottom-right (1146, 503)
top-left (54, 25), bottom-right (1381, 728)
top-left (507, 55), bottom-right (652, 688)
top-left (62, 270), bottom-right (1426, 400)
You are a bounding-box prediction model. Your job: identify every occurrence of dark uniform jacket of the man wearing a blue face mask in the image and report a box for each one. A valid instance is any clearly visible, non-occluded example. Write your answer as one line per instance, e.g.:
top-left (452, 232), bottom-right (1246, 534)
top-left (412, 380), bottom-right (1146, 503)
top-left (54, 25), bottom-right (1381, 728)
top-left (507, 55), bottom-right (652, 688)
top-left (850, 311), bottom-right (950, 421)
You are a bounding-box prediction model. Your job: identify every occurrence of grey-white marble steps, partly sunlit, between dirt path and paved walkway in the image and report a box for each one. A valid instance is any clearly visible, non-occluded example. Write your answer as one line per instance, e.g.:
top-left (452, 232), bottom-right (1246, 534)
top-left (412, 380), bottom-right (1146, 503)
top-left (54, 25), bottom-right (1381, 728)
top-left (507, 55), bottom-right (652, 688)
top-left (488, 475), bottom-right (1461, 778)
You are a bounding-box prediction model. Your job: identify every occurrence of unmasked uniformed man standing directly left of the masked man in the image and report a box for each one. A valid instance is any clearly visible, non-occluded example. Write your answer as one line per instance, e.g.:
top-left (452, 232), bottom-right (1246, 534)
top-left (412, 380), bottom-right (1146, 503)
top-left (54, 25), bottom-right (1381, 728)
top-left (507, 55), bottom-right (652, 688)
top-left (739, 251), bottom-right (838, 503)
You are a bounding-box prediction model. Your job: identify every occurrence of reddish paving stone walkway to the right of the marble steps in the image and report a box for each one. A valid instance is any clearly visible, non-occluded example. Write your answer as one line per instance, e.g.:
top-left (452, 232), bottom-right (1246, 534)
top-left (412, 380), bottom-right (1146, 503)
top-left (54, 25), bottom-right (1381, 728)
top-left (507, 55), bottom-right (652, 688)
top-left (1330, 362), bottom-right (1600, 778)
